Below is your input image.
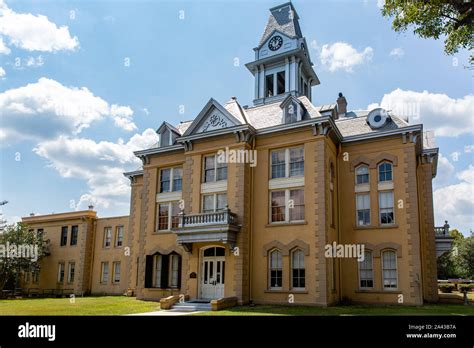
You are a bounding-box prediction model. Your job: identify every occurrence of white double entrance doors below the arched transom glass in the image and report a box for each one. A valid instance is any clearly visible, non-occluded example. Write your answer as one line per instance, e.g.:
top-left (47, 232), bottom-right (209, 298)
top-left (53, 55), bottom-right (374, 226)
top-left (201, 250), bottom-right (225, 300)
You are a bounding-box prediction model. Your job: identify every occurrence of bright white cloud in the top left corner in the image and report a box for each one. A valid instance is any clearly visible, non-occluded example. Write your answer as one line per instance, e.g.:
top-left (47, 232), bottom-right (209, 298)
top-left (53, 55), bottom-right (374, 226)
top-left (0, 0), bottom-right (79, 52)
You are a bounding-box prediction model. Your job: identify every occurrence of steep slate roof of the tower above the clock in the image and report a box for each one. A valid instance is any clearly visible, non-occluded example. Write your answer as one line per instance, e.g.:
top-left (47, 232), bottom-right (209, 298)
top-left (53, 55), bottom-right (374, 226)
top-left (258, 2), bottom-right (302, 47)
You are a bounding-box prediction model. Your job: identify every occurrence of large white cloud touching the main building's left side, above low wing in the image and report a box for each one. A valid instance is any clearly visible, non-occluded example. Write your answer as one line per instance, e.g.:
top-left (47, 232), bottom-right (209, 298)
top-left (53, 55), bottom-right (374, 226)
top-left (33, 128), bottom-right (158, 209)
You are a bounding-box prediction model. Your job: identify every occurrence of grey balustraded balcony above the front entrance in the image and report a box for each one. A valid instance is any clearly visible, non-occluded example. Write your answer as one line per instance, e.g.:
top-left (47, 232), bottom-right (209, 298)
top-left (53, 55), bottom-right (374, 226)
top-left (173, 206), bottom-right (240, 252)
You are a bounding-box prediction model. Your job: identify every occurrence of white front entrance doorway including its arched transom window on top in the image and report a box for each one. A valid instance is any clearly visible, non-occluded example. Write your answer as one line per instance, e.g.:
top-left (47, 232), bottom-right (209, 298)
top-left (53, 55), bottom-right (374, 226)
top-left (200, 246), bottom-right (225, 300)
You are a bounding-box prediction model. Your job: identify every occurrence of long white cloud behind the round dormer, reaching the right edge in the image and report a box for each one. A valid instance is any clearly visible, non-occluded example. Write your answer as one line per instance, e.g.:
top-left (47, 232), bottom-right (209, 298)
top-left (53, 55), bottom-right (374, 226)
top-left (372, 88), bottom-right (474, 137)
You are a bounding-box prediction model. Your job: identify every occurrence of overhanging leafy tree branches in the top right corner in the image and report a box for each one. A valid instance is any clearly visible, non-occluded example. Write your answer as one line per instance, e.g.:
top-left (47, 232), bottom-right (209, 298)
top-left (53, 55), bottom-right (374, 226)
top-left (382, 0), bottom-right (474, 64)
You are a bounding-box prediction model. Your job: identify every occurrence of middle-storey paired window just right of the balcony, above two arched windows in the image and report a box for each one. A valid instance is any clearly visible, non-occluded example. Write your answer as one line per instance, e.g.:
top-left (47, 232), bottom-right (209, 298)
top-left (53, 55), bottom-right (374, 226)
top-left (270, 189), bottom-right (304, 222)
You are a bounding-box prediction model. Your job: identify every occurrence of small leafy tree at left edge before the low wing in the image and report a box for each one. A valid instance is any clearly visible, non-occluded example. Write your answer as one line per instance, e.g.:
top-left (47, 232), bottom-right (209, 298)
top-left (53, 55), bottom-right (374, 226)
top-left (0, 223), bottom-right (45, 290)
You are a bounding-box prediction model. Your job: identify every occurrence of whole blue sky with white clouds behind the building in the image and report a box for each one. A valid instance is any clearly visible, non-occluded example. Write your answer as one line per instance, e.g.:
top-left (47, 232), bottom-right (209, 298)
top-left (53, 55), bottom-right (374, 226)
top-left (0, 0), bottom-right (474, 234)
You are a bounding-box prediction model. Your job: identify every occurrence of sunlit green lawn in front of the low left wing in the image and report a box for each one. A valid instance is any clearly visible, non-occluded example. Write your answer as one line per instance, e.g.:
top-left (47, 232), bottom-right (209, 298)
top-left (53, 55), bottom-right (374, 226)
top-left (0, 296), bottom-right (159, 316)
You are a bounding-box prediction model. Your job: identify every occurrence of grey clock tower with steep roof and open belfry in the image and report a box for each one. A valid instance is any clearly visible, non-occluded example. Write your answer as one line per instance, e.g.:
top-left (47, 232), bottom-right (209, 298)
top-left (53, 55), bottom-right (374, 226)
top-left (245, 2), bottom-right (319, 106)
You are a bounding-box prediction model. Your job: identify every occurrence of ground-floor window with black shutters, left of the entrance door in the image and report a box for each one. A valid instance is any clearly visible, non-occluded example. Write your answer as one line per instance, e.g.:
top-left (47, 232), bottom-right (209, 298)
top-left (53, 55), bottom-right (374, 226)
top-left (153, 253), bottom-right (181, 289)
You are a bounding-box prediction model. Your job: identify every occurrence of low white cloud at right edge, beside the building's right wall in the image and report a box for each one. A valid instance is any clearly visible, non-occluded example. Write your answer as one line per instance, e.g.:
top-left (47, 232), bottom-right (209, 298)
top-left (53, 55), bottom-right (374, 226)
top-left (433, 165), bottom-right (474, 234)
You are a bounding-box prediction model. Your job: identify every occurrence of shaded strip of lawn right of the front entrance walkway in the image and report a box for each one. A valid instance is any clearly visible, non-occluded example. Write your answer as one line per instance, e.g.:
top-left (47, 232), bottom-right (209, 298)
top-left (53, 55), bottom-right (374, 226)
top-left (194, 304), bottom-right (474, 315)
